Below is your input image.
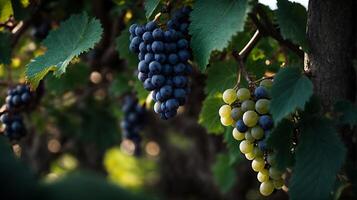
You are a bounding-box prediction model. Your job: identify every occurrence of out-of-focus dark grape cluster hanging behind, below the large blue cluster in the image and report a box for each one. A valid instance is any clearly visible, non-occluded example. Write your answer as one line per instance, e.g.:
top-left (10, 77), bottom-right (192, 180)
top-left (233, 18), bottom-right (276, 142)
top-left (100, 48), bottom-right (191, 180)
top-left (120, 96), bottom-right (146, 155)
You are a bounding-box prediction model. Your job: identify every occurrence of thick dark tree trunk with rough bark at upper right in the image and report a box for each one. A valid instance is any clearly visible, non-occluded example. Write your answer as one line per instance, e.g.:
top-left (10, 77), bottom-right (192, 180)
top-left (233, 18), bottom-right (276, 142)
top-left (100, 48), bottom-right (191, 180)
top-left (305, 0), bottom-right (357, 111)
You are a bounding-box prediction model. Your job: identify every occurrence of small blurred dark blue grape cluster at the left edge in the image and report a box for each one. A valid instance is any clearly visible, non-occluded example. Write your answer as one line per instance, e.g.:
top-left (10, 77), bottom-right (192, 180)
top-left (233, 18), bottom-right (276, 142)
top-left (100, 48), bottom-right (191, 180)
top-left (0, 84), bottom-right (34, 140)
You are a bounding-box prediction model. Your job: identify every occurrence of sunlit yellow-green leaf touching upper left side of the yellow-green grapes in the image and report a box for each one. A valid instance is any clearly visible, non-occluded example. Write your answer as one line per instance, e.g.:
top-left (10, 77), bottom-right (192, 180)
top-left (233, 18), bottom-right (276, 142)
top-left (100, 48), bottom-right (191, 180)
top-left (198, 95), bottom-right (224, 134)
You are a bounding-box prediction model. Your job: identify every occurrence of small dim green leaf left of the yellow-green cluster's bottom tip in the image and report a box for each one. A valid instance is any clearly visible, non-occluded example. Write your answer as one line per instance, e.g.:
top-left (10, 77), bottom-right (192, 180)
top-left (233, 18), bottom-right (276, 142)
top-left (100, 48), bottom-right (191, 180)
top-left (212, 154), bottom-right (237, 193)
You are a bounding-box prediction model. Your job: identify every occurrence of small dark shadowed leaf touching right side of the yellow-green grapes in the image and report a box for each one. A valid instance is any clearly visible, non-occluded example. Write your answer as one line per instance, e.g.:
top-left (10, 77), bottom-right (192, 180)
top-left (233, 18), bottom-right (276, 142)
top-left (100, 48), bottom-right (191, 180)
top-left (267, 119), bottom-right (294, 171)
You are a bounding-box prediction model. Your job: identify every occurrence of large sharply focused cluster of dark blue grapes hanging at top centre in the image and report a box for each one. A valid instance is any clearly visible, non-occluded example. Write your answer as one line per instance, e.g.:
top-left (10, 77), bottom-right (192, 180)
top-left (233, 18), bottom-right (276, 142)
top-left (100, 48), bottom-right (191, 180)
top-left (129, 7), bottom-right (192, 119)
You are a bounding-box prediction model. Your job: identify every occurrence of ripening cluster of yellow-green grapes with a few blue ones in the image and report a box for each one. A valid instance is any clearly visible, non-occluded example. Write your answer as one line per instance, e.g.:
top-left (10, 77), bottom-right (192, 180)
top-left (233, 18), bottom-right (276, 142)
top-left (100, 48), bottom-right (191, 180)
top-left (219, 79), bottom-right (284, 196)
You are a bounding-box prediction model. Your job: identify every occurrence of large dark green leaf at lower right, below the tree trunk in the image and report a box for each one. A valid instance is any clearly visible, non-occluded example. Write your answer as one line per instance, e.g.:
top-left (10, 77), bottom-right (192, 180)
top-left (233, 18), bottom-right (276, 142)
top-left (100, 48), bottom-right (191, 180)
top-left (289, 117), bottom-right (346, 200)
